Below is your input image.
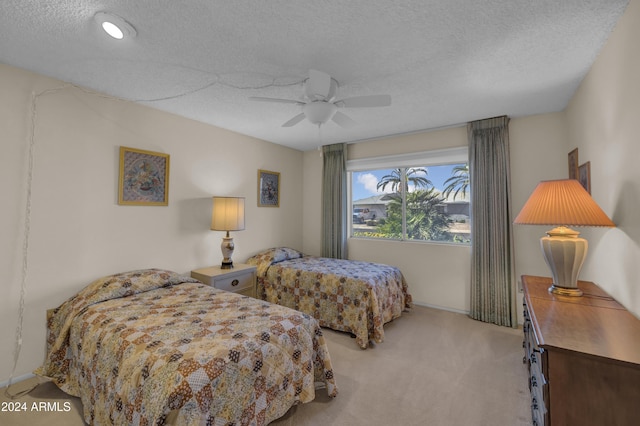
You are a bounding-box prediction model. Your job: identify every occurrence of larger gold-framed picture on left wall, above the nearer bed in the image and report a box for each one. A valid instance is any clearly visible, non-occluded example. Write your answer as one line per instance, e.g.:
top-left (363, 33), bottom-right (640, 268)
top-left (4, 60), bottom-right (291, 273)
top-left (118, 146), bottom-right (169, 206)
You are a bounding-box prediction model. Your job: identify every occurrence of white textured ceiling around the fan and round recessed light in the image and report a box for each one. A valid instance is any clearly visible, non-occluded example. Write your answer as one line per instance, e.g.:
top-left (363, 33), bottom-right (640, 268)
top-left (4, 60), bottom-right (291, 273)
top-left (0, 0), bottom-right (628, 150)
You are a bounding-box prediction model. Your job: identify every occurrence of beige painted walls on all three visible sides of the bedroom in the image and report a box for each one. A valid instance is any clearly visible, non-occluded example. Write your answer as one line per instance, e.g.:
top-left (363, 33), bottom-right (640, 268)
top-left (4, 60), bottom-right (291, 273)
top-left (0, 0), bottom-right (640, 382)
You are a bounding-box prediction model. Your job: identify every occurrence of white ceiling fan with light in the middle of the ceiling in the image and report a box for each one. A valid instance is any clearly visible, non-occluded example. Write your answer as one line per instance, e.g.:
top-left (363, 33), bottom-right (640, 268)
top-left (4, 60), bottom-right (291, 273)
top-left (249, 70), bottom-right (391, 128)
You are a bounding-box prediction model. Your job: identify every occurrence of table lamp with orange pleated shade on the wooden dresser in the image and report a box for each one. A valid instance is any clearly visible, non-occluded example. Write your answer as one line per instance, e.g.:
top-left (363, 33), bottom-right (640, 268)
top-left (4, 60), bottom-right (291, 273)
top-left (513, 179), bottom-right (616, 296)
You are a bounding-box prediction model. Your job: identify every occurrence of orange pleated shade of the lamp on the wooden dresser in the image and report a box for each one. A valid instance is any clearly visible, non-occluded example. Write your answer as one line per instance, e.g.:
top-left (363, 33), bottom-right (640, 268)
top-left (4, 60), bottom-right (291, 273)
top-left (513, 179), bottom-right (616, 227)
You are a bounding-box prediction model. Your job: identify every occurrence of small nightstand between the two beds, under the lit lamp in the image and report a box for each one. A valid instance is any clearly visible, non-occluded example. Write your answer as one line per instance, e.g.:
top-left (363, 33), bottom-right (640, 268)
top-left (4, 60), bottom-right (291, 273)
top-left (191, 263), bottom-right (256, 297)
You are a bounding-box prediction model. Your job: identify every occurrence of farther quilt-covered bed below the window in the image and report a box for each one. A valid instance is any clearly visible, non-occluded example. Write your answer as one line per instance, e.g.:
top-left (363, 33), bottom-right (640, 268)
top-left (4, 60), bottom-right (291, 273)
top-left (246, 247), bottom-right (412, 349)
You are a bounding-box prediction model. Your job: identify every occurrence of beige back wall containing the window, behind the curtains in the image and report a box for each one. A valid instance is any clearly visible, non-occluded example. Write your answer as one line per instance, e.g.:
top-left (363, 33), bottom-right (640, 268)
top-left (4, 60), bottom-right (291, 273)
top-left (303, 118), bottom-right (567, 314)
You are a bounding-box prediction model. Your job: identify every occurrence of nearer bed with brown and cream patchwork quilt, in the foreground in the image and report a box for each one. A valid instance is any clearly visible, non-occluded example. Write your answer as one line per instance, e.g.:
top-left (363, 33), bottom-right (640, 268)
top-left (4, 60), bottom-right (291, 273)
top-left (35, 269), bottom-right (337, 425)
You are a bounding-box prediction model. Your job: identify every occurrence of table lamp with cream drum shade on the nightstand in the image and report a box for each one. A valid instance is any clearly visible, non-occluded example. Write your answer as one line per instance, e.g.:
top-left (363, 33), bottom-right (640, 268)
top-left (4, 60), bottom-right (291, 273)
top-left (211, 197), bottom-right (244, 269)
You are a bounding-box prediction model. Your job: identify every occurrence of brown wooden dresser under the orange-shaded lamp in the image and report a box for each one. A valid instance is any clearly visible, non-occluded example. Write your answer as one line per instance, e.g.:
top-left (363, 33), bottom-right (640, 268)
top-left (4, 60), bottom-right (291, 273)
top-left (522, 275), bottom-right (640, 426)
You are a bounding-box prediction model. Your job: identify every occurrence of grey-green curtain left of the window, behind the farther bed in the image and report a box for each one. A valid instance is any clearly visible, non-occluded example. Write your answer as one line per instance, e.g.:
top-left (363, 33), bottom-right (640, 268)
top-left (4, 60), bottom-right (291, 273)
top-left (322, 143), bottom-right (348, 259)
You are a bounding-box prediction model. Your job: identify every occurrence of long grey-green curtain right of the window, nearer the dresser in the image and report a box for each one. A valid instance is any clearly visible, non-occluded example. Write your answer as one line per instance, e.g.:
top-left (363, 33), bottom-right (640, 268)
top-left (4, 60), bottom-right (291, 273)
top-left (467, 116), bottom-right (518, 327)
